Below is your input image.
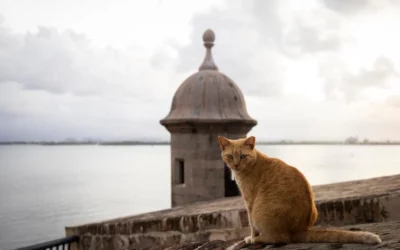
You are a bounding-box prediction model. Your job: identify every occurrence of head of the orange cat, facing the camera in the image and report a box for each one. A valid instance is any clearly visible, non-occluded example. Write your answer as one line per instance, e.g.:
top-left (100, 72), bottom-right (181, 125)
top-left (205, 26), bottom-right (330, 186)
top-left (218, 136), bottom-right (257, 171)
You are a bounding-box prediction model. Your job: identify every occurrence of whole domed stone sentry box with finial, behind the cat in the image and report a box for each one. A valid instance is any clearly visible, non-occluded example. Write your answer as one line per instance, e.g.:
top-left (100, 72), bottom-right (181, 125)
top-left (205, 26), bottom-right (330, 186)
top-left (160, 29), bottom-right (257, 207)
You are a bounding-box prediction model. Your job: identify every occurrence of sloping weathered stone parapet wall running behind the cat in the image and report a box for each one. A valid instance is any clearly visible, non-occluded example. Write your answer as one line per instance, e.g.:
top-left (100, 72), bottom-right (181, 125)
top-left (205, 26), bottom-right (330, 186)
top-left (66, 175), bottom-right (400, 250)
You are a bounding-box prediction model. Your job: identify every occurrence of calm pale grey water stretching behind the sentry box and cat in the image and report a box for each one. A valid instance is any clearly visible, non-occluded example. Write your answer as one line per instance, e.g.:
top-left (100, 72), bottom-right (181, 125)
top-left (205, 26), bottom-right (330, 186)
top-left (0, 145), bottom-right (400, 250)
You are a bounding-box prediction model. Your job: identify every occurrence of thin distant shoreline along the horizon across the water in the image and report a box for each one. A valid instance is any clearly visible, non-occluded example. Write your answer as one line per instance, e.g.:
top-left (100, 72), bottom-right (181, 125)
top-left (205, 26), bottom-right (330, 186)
top-left (0, 141), bottom-right (400, 146)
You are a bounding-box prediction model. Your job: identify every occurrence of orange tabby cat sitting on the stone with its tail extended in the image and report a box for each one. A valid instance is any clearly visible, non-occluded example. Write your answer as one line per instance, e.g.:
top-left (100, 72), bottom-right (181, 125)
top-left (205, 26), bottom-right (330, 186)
top-left (218, 136), bottom-right (381, 244)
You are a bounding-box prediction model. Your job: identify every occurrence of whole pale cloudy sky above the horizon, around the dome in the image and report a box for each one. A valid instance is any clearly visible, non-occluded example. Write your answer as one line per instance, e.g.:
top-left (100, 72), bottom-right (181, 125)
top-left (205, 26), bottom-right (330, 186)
top-left (0, 0), bottom-right (400, 141)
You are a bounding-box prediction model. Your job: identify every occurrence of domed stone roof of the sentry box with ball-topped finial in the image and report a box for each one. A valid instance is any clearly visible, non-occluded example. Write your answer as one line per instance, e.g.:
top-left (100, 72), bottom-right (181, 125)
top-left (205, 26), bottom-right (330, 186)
top-left (160, 29), bottom-right (257, 126)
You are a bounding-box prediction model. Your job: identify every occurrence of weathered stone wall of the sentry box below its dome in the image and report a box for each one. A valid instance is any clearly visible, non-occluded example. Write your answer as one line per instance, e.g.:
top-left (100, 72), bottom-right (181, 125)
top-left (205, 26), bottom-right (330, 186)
top-left (168, 122), bottom-right (250, 207)
